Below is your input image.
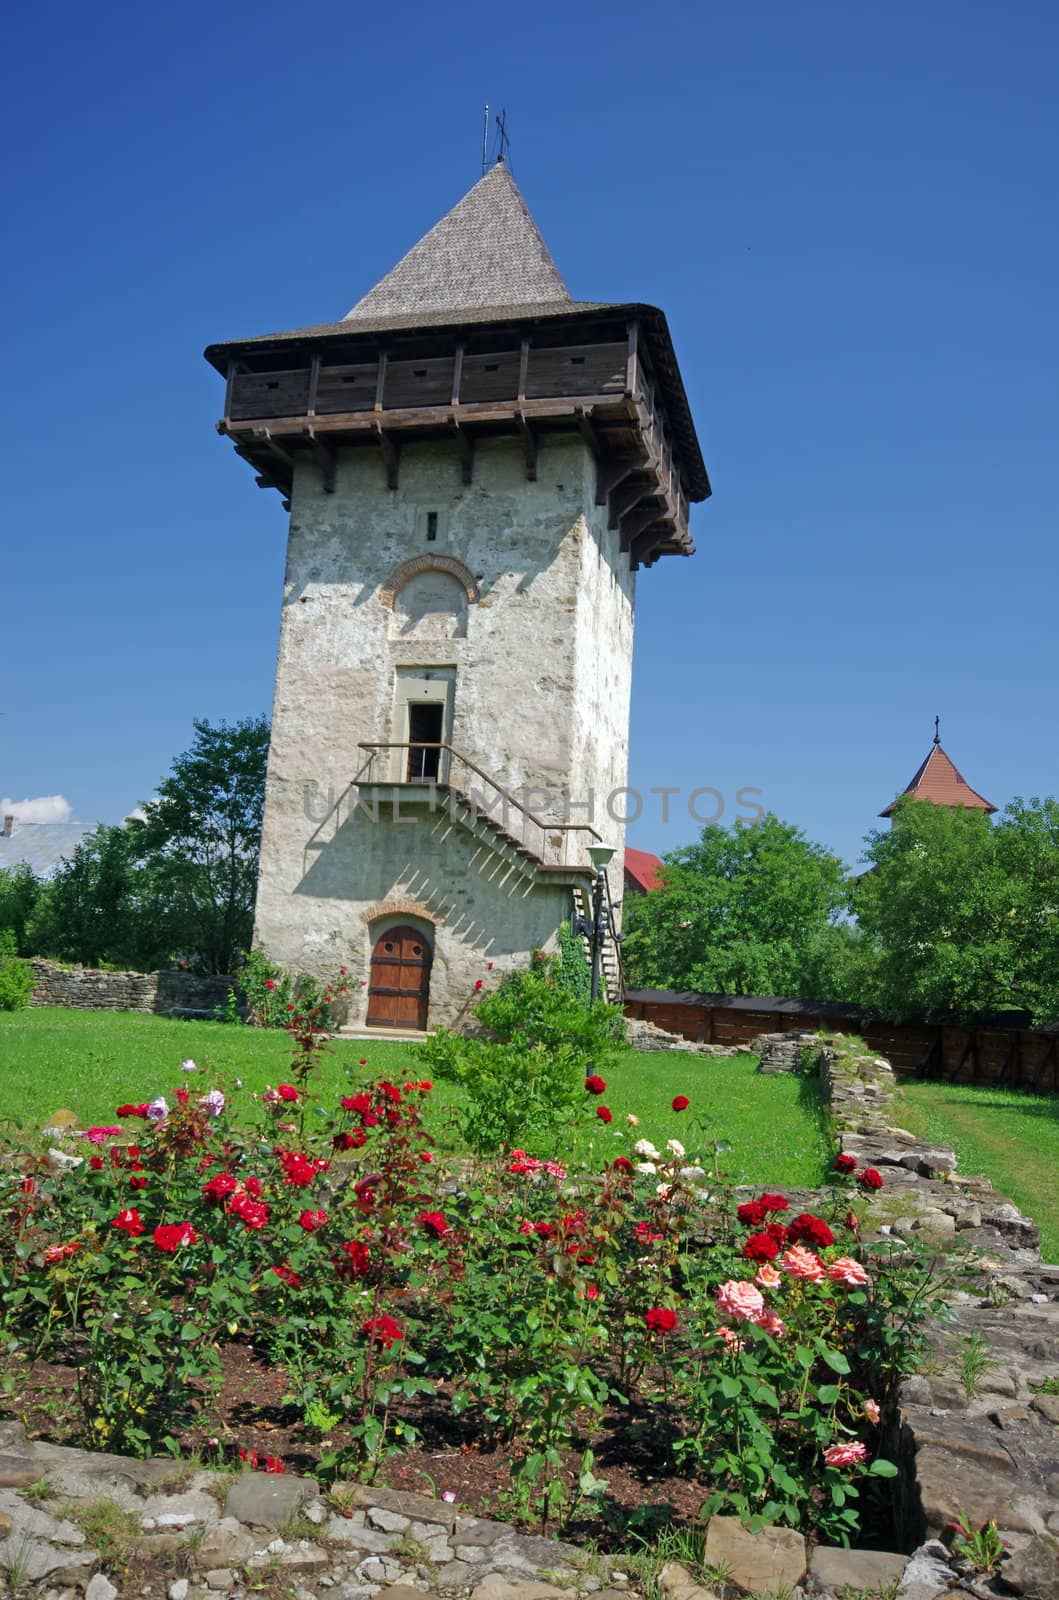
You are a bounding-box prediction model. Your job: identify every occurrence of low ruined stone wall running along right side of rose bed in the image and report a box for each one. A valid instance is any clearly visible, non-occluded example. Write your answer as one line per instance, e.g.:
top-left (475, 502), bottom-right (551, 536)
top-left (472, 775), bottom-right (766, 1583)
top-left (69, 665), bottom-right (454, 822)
top-left (800, 1037), bottom-right (1059, 1555)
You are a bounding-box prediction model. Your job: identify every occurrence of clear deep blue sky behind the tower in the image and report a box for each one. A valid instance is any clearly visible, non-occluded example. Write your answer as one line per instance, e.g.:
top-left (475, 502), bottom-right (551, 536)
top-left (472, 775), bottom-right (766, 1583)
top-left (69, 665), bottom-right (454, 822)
top-left (0, 0), bottom-right (1059, 862)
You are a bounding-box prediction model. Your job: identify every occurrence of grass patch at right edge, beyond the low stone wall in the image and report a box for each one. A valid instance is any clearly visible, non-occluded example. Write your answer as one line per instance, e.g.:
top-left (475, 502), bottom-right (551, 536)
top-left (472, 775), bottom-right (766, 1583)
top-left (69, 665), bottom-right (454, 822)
top-left (899, 1080), bottom-right (1059, 1261)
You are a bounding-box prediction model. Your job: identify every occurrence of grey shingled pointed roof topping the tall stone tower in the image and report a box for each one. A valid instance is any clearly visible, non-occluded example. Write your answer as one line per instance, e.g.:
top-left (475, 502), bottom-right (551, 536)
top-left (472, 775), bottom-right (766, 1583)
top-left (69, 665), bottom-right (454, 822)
top-left (344, 162), bottom-right (573, 323)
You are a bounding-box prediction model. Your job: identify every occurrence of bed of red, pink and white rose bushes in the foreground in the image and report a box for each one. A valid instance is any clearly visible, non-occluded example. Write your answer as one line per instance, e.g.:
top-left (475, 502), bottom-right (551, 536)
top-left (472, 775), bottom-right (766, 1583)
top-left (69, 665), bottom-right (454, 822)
top-left (0, 1011), bottom-right (959, 1541)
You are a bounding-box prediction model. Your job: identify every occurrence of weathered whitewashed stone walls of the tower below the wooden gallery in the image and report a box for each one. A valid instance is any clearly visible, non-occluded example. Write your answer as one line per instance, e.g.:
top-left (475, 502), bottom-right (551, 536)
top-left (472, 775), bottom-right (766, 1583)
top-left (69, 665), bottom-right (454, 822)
top-left (254, 437), bottom-right (635, 1024)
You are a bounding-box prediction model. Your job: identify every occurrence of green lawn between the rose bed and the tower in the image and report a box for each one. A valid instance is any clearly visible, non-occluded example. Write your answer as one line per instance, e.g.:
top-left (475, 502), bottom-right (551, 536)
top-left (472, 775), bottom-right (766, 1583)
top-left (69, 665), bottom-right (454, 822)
top-left (0, 1006), bottom-right (830, 1187)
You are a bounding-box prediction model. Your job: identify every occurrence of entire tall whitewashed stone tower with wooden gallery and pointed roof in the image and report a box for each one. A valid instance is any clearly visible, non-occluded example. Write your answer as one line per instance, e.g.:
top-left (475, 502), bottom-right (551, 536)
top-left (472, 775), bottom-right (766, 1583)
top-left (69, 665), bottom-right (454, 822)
top-left (206, 163), bottom-right (710, 1029)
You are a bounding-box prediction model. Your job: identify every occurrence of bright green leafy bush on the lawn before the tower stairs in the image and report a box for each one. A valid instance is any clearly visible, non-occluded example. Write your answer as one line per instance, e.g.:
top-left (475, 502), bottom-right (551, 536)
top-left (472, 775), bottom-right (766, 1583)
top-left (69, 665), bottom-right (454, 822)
top-left (418, 958), bottom-right (624, 1154)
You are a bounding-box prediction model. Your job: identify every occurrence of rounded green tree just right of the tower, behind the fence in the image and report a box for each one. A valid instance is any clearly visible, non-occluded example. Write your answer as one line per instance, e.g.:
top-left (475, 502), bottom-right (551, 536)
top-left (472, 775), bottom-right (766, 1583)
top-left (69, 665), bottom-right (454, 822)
top-left (622, 813), bottom-right (851, 1000)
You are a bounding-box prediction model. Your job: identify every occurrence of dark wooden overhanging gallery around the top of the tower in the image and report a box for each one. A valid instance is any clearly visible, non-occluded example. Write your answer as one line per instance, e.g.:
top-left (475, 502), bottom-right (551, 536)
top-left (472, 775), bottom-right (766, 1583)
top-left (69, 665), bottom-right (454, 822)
top-left (218, 320), bottom-right (709, 566)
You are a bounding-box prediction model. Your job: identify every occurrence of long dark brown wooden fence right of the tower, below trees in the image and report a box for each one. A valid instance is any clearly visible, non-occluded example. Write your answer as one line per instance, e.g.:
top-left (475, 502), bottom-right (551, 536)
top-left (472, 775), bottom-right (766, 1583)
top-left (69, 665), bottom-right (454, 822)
top-left (625, 989), bottom-right (1059, 1093)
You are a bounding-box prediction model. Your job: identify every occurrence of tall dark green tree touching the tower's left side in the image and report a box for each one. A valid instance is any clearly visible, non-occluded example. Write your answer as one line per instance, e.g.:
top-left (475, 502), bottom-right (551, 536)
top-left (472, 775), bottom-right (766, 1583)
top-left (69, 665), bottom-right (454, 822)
top-left (134, 717), bottom-right (269, 973)
